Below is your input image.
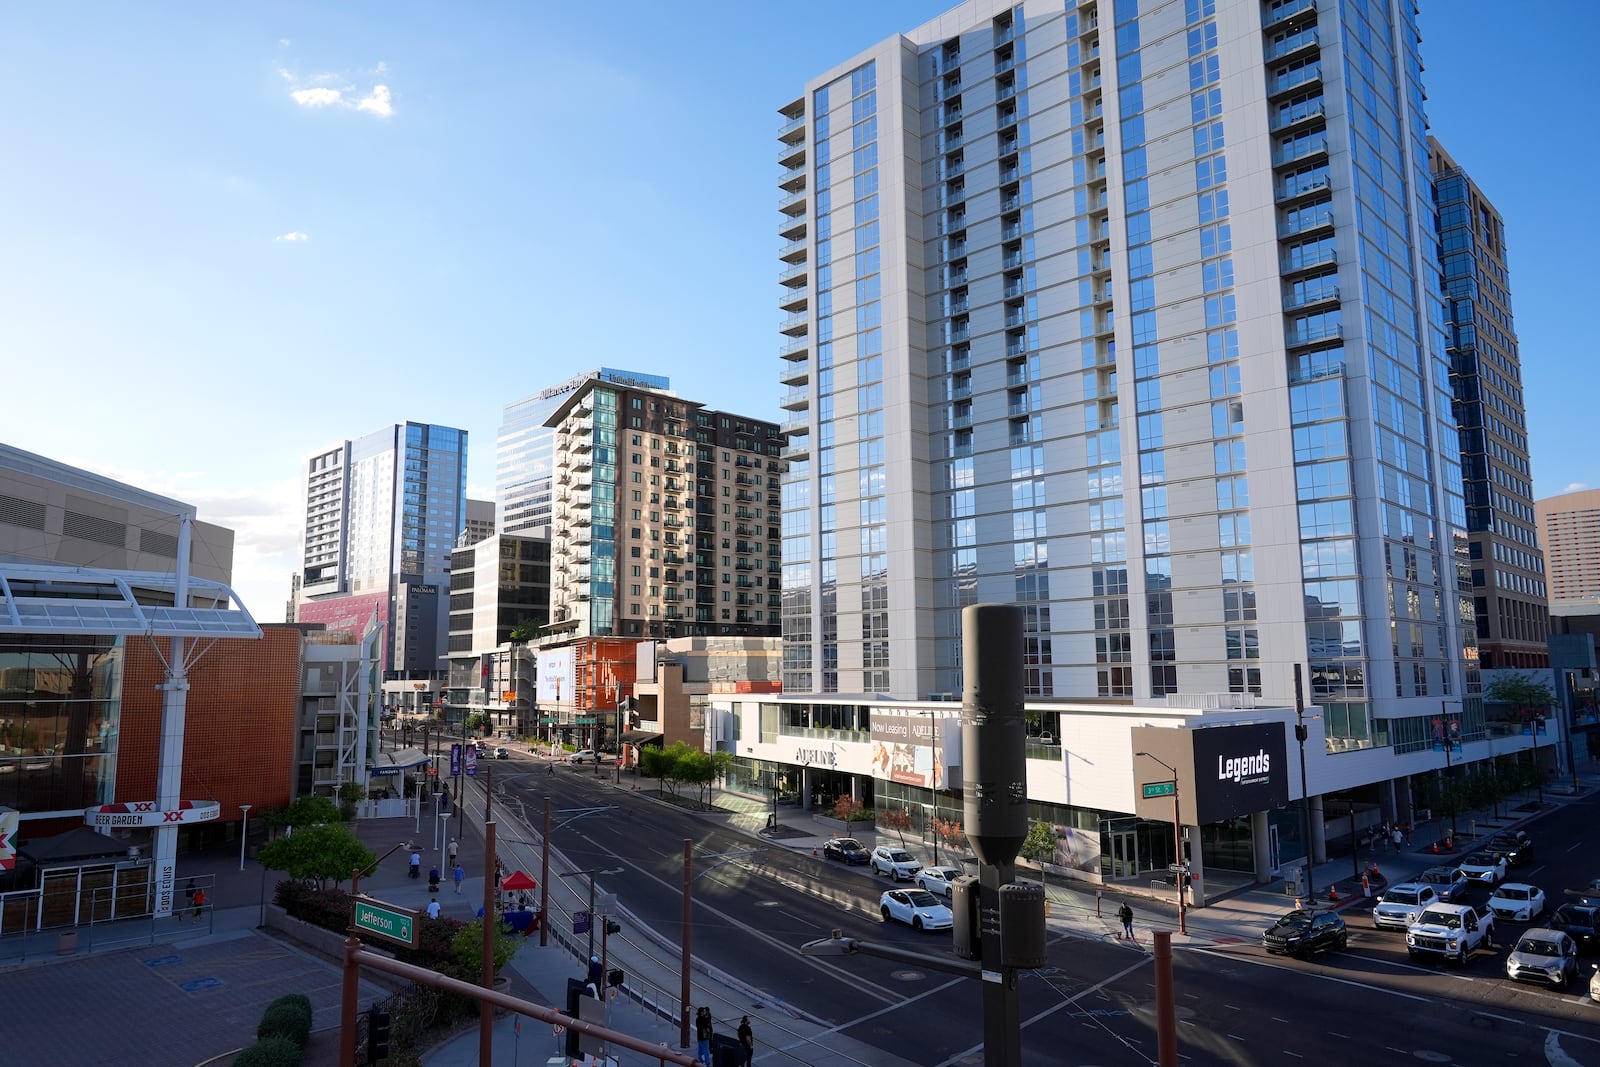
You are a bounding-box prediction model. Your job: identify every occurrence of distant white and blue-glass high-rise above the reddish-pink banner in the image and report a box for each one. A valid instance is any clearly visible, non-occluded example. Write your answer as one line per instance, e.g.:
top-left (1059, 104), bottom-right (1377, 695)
top-left (296, 422), bottom-right (467, 678)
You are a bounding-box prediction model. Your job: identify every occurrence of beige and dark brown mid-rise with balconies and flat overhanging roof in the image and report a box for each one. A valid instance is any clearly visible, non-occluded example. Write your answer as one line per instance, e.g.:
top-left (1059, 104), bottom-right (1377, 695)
top-left (549, 378), bottom-right (782, 638)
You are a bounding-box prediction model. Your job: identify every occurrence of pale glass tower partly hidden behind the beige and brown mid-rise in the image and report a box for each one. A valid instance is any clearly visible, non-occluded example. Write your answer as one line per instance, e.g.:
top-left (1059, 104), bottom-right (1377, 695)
top-left (494, 366), bottom-right (672, 533)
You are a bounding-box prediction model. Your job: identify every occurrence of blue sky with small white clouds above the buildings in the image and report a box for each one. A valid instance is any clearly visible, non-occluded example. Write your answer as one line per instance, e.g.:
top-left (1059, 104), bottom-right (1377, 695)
top-left (0, 0), bottom-right (1600, 621)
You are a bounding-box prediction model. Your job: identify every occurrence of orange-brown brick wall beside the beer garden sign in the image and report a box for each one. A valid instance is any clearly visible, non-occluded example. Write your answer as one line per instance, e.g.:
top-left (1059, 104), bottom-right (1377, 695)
top-left (117, 625), bottom-right (301, 822)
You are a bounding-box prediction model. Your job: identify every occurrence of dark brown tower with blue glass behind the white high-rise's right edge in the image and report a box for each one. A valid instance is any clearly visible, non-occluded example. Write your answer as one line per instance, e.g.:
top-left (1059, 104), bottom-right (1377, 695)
top-left (1427, 138), bottom-right (1550, 670)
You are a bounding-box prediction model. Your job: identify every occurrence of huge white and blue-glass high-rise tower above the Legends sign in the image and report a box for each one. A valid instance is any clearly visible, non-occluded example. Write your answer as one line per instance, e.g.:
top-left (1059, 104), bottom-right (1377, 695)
top-left (779, 0), bottom-right (1480, 747)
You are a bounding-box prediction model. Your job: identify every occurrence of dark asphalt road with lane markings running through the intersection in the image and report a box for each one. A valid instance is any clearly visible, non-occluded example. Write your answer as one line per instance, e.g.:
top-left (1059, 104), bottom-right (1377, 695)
top-left (496, 760), bottom-right (1600, 1067)
